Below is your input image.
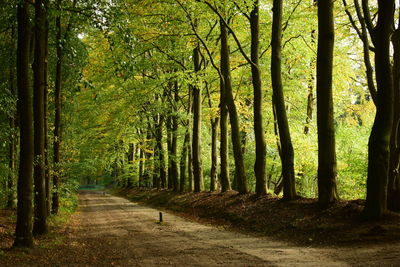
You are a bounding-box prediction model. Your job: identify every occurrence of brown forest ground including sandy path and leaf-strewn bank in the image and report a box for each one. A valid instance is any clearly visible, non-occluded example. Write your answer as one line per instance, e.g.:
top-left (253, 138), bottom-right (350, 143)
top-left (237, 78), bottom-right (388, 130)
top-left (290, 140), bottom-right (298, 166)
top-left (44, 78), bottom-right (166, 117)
top-left (0, 190), bottom-right (400, 266)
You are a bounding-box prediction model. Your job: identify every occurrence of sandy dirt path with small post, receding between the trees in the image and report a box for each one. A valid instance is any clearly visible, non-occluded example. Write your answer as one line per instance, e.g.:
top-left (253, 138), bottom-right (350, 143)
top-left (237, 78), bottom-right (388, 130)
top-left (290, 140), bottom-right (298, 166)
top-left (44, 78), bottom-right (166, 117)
top-left (48, 192), bottom-right (350, 266)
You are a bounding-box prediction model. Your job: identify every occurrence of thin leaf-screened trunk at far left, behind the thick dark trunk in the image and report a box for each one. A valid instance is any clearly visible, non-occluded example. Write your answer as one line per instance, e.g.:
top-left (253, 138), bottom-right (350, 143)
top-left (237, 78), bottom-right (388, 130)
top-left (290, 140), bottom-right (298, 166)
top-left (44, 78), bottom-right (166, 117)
top-left (7, 25), bottom-right (18, 209)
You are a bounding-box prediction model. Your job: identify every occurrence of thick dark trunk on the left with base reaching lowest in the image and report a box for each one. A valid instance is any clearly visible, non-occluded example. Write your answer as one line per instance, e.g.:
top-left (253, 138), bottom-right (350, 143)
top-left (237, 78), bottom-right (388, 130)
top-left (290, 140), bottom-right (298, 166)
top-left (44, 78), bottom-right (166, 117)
top-left (13, 0), bottom-right (34, 247)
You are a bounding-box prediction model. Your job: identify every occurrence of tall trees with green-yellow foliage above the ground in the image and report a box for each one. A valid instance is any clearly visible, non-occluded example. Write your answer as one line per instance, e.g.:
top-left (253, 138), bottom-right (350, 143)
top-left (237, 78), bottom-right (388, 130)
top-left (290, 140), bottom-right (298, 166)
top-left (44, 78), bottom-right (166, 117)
top-left (0, 0), bottom-right (400, 256)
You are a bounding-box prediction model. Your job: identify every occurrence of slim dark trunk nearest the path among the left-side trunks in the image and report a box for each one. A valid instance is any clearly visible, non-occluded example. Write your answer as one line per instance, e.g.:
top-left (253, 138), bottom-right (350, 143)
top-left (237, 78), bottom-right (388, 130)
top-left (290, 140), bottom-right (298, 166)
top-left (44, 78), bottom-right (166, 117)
top-left (51, 0), bottom-right (63, 214)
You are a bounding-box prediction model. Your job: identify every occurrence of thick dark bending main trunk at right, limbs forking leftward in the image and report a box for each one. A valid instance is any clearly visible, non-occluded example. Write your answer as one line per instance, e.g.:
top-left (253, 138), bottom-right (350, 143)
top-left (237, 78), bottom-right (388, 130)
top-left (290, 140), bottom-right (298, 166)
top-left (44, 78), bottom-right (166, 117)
top-left (364, 0), bottom-right (394, 218)
